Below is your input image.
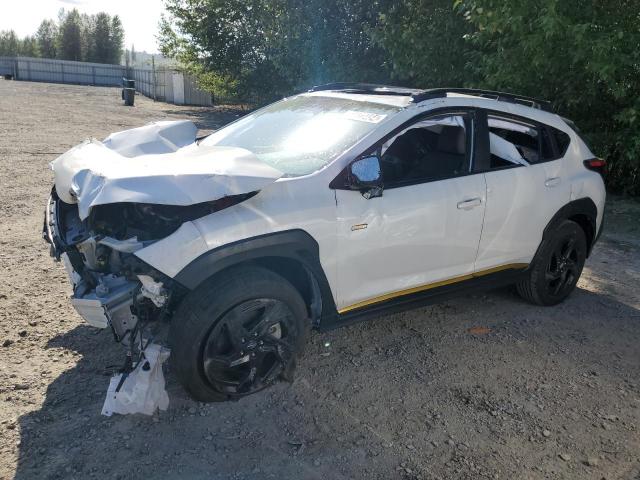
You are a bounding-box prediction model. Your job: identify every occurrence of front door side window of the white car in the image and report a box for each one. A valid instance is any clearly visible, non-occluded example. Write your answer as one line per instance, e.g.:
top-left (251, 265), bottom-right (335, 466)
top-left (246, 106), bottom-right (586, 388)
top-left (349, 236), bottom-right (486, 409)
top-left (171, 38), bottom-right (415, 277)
top-left (380, 115), bottom-right (471, 188)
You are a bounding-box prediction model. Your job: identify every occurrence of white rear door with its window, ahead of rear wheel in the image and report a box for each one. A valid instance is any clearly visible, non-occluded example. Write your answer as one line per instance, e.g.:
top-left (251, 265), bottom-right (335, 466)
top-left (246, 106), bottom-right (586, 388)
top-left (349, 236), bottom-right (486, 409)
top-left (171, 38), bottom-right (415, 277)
top-left (475, 112), bottom-right (571, 271)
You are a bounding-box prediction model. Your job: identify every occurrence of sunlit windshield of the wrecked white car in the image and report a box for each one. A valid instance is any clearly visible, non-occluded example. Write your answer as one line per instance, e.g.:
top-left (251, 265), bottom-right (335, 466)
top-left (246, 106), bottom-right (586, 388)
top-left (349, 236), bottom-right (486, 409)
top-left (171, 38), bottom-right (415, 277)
top-left (202, 96), bottom-right (400, 177)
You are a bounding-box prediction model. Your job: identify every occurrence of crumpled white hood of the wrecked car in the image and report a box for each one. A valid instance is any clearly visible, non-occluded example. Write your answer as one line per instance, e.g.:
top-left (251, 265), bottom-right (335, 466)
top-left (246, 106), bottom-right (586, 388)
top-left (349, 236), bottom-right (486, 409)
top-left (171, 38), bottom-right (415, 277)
top-left (51, 120), bottom-right (283, 219)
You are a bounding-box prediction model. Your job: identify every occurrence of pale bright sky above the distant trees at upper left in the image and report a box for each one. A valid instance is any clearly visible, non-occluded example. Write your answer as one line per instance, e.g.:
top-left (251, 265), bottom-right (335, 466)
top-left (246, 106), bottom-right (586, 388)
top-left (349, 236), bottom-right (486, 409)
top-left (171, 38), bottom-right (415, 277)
top-left (0, 0), bottom-right (164, 53)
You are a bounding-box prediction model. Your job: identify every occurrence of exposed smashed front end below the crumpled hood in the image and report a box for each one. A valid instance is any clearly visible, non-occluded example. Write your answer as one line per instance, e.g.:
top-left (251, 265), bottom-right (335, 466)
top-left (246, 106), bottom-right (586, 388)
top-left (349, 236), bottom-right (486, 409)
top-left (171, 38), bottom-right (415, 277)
top-left (43, 189), bottom-right (185, 346)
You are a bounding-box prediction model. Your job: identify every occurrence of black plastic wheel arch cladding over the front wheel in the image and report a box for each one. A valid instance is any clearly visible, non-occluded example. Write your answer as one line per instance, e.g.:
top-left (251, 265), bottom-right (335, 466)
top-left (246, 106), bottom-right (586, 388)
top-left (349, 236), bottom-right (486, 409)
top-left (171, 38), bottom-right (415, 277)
top-left (174, 229), bottom-right (337, 323)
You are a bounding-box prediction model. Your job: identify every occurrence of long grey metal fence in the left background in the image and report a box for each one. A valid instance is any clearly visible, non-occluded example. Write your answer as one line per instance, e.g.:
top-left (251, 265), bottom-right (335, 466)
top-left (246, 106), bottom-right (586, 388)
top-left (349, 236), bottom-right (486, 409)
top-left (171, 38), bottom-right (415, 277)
top-left (0, 57), bottom-right (213, 106)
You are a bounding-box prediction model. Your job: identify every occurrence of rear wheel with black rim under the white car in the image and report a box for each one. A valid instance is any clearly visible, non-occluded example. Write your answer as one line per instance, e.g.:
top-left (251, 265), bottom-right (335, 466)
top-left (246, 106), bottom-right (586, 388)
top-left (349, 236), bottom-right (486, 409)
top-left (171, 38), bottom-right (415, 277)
top-left (516, 220), bottom-right (587, 306)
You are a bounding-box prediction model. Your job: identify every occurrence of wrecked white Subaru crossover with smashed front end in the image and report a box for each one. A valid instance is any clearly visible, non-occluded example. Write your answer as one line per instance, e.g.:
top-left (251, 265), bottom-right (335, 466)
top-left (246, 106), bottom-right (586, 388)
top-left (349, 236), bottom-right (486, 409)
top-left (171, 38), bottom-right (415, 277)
top-left (44, 84), bottom-right (605, 402)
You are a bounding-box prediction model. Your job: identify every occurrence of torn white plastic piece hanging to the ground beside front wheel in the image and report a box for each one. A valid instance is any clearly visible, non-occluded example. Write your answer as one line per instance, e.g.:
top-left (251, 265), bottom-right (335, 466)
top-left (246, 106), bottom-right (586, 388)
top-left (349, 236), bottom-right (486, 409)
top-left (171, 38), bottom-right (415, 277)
top-left (102, 343), bottom-right (169, 417)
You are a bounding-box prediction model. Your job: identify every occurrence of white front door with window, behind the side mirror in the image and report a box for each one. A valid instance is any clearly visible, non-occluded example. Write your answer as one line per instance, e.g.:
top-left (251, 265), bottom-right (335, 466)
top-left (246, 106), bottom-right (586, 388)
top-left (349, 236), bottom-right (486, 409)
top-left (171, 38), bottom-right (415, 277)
top-left (336, 112), bottom-right (486, 313)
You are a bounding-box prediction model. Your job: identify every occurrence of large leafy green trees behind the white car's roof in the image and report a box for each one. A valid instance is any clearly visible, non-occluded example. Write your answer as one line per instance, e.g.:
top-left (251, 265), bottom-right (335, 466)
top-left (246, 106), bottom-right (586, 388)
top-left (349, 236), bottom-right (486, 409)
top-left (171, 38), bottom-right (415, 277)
top-left (160, 0), bottom-right (640, 195)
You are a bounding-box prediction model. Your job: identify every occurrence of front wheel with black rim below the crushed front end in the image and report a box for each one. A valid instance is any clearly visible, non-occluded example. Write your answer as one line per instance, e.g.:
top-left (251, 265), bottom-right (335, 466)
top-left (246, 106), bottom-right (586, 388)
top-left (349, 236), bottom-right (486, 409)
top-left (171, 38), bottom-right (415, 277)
top-left (169, 267), bottom-right (310, 402)
